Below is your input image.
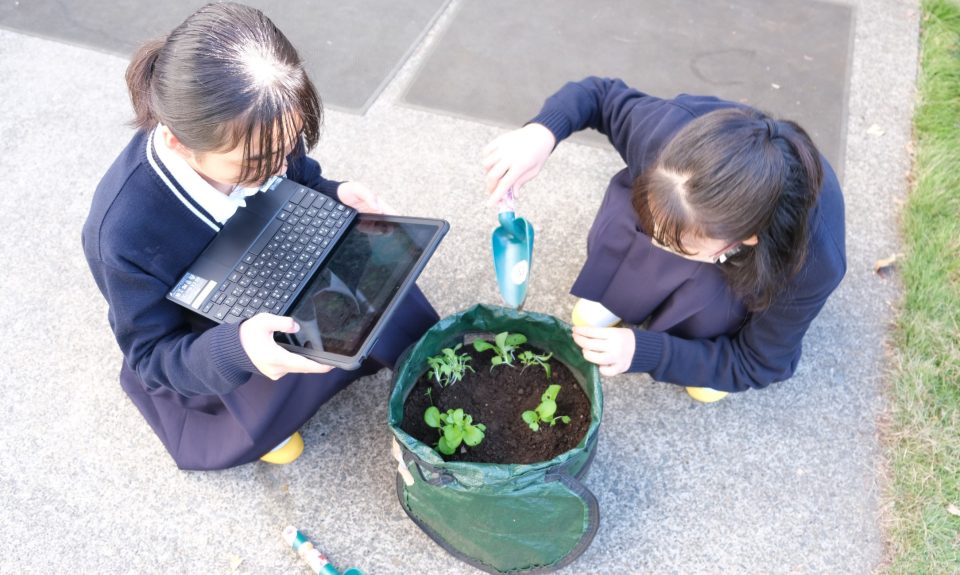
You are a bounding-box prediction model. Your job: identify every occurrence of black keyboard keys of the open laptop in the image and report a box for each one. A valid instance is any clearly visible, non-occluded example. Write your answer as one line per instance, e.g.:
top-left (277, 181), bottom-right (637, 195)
top-left (201, 188), bottom-right (354, 323)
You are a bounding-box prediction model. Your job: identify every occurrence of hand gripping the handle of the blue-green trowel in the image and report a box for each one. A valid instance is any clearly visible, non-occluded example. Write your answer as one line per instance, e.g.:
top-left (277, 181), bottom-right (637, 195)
top-left (483, 124), bottom-right (557, 206)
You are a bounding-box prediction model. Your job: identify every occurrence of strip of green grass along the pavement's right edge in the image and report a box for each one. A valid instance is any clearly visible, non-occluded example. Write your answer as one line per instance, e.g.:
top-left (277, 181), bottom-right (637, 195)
top-left (887, 0), bottom-right (960, 575)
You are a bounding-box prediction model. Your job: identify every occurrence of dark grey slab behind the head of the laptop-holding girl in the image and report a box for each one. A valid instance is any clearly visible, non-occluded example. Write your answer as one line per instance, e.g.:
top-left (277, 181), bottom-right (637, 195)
top-left (0, 0), bottom-right (448, 113)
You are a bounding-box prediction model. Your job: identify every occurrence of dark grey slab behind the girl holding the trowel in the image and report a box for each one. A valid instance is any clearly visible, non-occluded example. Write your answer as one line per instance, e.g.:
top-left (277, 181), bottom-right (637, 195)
top-left (404, 0), bottom-right (853, 178)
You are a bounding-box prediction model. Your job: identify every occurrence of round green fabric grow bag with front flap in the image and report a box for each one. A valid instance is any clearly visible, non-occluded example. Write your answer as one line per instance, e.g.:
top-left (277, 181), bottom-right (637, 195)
top-left (388, 305), bottom-right (603, 573)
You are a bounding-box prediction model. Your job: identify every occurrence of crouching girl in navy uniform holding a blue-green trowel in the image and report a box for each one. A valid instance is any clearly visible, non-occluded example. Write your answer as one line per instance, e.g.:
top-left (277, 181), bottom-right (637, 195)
top-left (483, 77), bottom-right (846, 401)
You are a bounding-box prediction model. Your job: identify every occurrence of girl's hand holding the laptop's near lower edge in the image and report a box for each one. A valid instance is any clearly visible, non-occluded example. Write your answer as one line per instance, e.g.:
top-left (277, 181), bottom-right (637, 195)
top-left (240, 313), bottom-right (333, 381)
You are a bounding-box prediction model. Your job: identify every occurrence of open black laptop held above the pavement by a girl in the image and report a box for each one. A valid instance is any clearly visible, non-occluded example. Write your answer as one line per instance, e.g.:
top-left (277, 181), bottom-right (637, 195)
top-left (167, 177), bottom-right (450, 369)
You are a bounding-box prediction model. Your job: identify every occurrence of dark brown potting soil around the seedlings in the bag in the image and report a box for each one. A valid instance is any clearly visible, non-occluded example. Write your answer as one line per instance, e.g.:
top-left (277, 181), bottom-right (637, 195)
top-left (400, 344), bottom-right (590, 463)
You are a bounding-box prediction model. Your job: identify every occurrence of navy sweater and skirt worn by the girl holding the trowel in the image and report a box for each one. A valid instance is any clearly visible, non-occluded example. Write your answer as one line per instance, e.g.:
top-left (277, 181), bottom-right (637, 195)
top-left (531, 77), bottom-right (846, 391)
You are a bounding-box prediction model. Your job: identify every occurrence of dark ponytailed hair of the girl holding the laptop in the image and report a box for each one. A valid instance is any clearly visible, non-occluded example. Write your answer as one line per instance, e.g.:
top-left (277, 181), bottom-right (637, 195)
top-left (126, 2), bottom-right (323, 186)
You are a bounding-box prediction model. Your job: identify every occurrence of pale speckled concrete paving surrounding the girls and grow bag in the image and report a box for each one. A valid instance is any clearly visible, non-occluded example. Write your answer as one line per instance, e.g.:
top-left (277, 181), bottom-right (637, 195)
top-left (0, 0), bottom-right (919, 575)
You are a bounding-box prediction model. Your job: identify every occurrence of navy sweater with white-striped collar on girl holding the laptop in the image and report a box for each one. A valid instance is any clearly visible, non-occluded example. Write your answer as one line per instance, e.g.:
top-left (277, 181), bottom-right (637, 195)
top-left (82, 132), bottom-right (339, 397)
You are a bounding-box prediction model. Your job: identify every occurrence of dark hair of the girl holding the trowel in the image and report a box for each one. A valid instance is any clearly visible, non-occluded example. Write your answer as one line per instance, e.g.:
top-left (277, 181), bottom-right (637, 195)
top-left (633, 108), bottom-right (823, 312)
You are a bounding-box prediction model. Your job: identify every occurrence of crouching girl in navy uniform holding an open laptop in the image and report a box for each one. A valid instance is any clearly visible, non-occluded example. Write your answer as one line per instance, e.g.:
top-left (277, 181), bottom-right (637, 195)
top-left (83, 3), bottom-right (438, 469)
